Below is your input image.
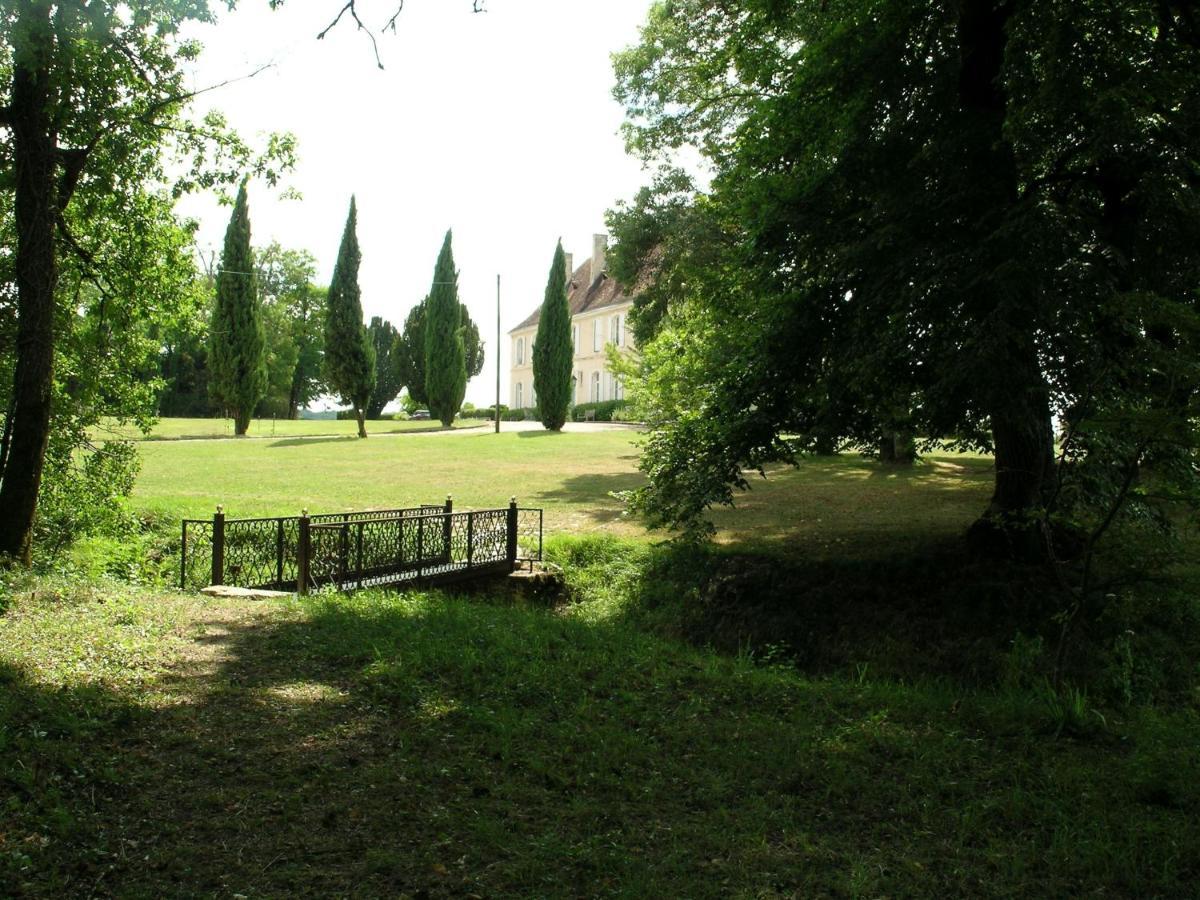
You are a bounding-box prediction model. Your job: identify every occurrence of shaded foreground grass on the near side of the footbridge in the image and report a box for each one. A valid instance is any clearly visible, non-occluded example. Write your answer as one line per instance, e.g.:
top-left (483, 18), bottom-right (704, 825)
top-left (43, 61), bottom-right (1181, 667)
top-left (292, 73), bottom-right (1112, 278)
top-left (0, 580), bottom-right (1200, 898)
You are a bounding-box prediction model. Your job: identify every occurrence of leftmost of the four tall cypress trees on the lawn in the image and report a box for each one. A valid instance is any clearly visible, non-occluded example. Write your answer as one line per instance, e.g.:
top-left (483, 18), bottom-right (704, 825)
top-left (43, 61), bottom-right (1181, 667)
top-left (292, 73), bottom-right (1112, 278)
top-left (209, 181), bottom-right (266, 434)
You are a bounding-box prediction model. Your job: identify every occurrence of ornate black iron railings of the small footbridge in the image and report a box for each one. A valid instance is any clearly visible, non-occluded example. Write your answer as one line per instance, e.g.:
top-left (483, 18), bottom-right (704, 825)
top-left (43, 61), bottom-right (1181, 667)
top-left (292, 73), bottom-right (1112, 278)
top-left (180, 497), bottom-right (542, 594)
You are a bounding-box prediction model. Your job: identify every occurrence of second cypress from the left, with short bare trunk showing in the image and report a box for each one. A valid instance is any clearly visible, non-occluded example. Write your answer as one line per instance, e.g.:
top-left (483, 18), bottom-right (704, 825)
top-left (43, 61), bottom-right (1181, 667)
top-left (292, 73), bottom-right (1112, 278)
top-left (325, 197), bottom-right (376, 438)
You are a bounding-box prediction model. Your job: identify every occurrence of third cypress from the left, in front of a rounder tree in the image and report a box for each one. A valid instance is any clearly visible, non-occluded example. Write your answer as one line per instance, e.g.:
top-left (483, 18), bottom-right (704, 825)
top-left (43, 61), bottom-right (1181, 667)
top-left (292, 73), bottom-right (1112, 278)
top-left (425, 230), bottom-right (467, 428)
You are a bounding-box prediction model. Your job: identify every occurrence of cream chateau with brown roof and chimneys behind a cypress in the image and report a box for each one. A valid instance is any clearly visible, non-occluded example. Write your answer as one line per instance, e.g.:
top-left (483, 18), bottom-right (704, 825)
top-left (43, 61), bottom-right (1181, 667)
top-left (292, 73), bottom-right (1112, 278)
top-left (509, 234), bottom-right (634, 409)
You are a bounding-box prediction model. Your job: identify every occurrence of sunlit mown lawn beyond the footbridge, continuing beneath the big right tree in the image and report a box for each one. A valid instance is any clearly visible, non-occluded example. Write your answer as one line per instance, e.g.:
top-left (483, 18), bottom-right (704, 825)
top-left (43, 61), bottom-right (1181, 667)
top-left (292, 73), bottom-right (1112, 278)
top-left (134, 422), bottom-right (991, 556)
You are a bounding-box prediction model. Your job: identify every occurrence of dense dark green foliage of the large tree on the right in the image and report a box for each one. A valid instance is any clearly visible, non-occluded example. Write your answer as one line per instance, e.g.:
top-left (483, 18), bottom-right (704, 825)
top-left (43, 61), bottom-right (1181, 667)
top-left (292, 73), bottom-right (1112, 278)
top-left (612, 0), bottom-right (1200, 547)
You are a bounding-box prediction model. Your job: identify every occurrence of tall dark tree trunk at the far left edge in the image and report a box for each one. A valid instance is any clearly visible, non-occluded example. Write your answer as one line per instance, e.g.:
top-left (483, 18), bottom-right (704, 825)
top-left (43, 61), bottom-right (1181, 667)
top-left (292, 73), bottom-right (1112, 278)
top-left (0, 1), bottom-right (58, 564)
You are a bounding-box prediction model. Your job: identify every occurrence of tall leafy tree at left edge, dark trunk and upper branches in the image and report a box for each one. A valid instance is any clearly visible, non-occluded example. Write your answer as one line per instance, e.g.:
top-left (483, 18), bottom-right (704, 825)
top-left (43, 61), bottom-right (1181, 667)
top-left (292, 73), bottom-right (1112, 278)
top-left (0, 0), bottom-right (292, 560)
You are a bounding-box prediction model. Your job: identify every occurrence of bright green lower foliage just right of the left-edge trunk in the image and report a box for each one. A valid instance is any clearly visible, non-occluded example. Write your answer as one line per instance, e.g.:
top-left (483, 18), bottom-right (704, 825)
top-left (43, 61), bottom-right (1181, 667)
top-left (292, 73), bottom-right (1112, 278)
top-left (0, 183), bottom-right (204, 568)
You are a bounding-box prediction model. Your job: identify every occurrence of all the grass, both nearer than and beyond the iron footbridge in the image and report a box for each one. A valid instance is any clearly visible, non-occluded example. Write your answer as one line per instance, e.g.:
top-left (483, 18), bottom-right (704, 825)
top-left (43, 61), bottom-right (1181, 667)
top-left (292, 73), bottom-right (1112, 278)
top-left (0, 431), bottom-right (1200, 898)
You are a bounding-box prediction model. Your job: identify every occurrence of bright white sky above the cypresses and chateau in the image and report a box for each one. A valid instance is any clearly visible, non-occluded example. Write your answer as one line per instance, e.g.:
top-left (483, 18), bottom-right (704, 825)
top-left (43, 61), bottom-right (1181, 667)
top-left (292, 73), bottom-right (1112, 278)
top-left (179, 0), bottom-right (650, 406)
